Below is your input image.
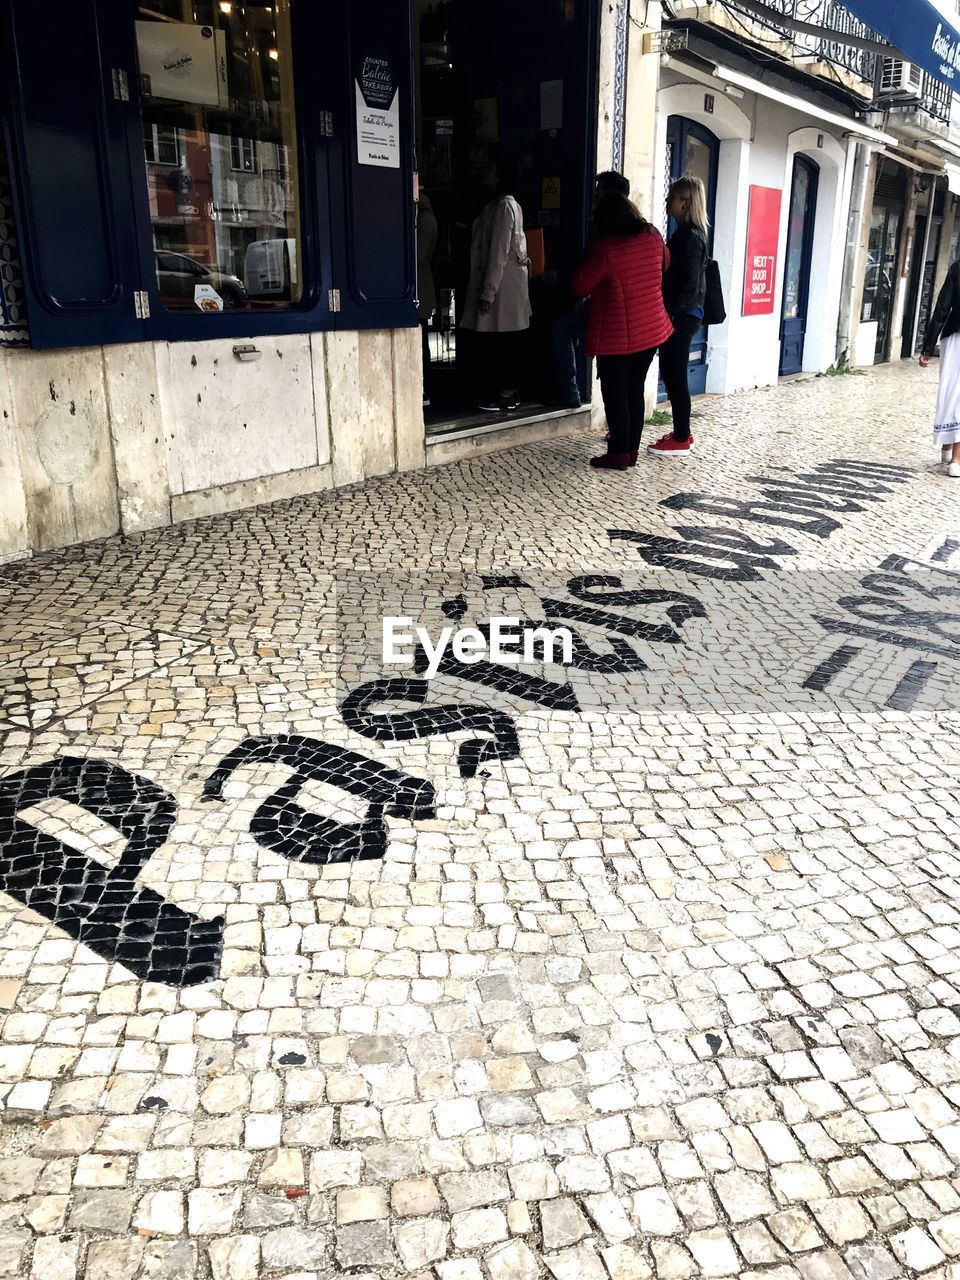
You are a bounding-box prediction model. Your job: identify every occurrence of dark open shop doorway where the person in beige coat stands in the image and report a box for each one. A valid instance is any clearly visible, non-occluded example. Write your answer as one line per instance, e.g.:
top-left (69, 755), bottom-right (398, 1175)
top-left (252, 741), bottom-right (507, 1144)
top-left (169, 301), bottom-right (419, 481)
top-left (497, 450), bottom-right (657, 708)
top-left (413, 0), bottom-right (599, 435)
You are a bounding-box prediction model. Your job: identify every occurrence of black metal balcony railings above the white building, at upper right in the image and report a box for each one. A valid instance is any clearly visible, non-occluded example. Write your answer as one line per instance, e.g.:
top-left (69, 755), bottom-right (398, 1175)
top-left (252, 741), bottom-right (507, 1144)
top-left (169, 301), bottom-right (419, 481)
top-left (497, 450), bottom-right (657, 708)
top-left (721, 0), bottom-right (954, 123)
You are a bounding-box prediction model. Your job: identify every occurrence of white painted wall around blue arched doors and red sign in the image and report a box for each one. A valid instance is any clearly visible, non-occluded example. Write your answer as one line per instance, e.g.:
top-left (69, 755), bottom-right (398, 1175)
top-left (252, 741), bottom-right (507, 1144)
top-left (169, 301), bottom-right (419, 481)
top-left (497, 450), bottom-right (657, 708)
top-left (657, 70), bottom-right (850, 394)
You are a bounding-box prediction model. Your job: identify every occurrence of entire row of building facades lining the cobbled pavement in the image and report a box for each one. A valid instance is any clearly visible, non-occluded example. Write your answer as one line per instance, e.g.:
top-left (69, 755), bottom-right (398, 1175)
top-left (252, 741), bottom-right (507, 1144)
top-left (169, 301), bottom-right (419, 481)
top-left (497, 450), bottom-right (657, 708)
top-left (0, 0), bottom-right (960, 562)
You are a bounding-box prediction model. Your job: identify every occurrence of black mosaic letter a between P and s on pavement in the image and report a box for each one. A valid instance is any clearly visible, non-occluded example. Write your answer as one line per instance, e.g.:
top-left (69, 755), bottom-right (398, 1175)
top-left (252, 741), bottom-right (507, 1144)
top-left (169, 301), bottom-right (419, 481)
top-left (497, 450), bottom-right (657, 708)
top-left (204, 733), bottom-right (436, 864)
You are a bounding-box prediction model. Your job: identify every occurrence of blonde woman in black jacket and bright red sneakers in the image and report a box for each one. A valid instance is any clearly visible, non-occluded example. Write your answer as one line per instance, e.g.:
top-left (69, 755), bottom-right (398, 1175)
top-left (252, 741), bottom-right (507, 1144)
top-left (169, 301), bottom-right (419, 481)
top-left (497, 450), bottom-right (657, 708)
top-left (648, 174), bottom-right (709, 458)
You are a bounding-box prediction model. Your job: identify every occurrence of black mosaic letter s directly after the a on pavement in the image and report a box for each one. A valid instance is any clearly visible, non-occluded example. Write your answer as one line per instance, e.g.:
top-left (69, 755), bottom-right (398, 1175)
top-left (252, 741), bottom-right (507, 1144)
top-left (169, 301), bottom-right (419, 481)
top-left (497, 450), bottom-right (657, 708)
top-left (340, 680), bottom-right (520, 778)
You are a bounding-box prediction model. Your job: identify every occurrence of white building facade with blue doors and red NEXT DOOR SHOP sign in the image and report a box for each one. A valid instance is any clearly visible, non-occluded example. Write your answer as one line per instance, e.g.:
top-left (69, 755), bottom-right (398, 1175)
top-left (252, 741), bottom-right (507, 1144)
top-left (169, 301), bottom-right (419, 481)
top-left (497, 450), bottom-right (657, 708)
top-left (657, 0), bottom-right (956, 393)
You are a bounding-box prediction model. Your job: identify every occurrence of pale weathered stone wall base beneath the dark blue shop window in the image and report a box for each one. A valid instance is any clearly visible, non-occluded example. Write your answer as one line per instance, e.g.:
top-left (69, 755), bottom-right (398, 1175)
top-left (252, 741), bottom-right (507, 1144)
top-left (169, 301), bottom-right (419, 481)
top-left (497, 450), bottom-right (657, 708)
top-left (0, 329), bottom-right (424, 561)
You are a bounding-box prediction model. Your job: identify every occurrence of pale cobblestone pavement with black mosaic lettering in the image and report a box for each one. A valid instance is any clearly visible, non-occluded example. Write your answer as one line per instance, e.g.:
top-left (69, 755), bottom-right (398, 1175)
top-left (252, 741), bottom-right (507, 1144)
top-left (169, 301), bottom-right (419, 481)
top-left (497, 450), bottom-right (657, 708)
top-left (0, 367), bottom-right (960, 1280)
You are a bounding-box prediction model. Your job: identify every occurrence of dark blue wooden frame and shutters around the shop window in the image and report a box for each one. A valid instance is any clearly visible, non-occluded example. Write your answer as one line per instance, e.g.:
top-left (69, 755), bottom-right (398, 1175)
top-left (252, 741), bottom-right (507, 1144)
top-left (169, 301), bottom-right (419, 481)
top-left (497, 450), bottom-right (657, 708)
top-left (0, 0), bottom-right (419, 347)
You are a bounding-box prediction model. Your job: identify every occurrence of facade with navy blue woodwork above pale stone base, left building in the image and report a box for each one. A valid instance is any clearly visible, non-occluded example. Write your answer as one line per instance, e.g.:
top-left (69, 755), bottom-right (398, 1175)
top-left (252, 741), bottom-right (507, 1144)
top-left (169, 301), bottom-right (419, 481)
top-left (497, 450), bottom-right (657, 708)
top-left (0, 0), bottom-right (659, 559)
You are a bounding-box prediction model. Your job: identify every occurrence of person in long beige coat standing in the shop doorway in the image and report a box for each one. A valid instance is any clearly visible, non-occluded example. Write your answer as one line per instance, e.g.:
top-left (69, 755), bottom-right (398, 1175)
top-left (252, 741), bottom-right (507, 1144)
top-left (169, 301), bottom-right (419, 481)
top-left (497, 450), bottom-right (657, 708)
top-left (460, 161), bottom-right (531, 413)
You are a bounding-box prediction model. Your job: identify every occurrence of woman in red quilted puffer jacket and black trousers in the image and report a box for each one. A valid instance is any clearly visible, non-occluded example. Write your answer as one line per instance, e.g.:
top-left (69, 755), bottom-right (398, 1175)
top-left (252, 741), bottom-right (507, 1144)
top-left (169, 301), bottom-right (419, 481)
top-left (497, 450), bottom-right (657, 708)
top-left (571, 192), bottom-right (673, 471)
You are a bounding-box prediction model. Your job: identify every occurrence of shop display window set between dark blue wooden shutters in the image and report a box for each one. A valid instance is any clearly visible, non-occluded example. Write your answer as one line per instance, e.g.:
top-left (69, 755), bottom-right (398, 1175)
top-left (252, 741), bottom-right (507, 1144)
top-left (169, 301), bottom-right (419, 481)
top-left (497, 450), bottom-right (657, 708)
top-left (137, 0), bottom-right (302, 315)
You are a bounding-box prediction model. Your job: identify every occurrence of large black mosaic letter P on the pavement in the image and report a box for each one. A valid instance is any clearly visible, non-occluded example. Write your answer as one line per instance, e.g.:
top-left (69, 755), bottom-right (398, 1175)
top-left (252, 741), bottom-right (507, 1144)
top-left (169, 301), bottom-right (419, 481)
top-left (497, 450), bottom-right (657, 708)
top-left (0, 755), bottom-right (223, 987)
